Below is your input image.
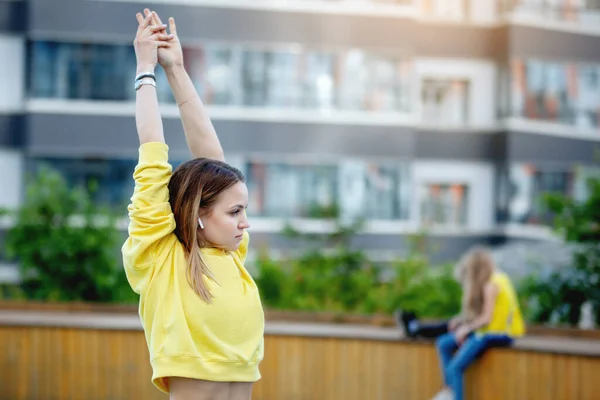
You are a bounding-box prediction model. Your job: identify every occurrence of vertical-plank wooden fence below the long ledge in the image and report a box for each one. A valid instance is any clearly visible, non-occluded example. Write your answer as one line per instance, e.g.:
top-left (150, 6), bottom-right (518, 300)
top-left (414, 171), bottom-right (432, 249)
top-left (0, 322), bottom-right (600, 400)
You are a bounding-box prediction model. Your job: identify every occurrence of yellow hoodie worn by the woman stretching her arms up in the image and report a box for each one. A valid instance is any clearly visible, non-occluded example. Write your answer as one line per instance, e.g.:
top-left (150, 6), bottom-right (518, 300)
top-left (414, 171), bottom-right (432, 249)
top-left (122, 143), bottom-right (264, 393)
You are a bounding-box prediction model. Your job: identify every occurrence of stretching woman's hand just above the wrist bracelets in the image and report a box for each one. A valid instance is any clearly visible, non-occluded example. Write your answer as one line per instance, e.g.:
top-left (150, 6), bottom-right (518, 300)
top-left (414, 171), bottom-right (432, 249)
top-left (133, 13), bottom-right (173, 73)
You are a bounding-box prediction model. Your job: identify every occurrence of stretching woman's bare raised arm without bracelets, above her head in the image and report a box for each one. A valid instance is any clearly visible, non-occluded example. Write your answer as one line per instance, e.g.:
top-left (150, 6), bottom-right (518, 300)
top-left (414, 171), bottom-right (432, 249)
top-left (144, 9), bottom-right (225, 161)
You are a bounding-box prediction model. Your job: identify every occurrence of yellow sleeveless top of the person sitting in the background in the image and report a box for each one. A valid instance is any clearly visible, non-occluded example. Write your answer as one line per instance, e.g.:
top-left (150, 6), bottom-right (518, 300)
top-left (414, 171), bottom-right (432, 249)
top-left (477, 272), bottom-right (525, 337)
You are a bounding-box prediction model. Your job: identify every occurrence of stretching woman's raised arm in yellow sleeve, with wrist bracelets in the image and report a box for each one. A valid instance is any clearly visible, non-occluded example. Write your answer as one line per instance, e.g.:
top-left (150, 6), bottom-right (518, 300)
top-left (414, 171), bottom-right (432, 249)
top-left (121, 14), bottom-right (175, 293)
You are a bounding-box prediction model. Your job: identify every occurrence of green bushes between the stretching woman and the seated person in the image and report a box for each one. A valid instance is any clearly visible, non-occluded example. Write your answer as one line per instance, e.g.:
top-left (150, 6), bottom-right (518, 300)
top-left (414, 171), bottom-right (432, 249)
top-left (256, 225), bottom-right (461, 318)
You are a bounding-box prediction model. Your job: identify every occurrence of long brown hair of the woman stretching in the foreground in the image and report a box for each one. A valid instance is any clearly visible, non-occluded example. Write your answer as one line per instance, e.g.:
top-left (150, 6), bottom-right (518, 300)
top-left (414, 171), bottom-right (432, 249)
top-left (169, 158), bottom-right (245, 303)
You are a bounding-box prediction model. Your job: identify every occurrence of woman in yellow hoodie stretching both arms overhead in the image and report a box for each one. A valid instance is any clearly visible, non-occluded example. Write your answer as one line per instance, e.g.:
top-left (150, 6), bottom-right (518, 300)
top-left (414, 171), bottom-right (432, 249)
top-left (122, 10), bottom-right (264, 400)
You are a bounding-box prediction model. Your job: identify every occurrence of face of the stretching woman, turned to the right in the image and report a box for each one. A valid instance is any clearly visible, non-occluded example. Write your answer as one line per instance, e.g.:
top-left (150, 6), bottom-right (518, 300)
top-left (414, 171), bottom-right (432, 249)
top-left (200, 182), bottom-right (250, 251)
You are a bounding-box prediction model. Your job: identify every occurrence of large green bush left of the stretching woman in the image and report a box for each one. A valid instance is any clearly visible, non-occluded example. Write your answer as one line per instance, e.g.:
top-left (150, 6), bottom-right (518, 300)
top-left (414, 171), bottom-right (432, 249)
top-left (6, 168), bottom-right (136, 302)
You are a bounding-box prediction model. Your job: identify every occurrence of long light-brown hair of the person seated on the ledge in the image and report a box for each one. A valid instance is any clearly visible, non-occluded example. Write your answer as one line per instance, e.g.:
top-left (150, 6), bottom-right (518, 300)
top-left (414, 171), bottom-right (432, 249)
top-left (455, 247), bottom-right (494, 320)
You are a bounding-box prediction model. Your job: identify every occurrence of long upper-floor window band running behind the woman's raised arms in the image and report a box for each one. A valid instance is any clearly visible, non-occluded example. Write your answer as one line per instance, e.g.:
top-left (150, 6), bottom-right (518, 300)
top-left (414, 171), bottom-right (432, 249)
top-left (29, 41), bottom-right (412, 113)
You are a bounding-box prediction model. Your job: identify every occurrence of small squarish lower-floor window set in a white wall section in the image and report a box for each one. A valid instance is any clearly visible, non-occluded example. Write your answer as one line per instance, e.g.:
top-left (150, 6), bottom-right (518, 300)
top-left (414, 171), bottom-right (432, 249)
top-left (420, 183), bottom-right (469, 226)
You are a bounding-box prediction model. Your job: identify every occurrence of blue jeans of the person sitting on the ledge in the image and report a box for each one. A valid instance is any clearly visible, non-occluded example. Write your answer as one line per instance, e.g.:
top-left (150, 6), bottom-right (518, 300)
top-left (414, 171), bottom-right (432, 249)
top-left (436, 332), bottom-right (513, 400)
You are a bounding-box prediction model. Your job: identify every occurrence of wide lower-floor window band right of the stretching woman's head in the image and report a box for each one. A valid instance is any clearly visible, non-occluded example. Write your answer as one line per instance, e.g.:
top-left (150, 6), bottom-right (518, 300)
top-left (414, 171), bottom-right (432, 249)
top-left (246, 161), bottom-right (410, 220)
